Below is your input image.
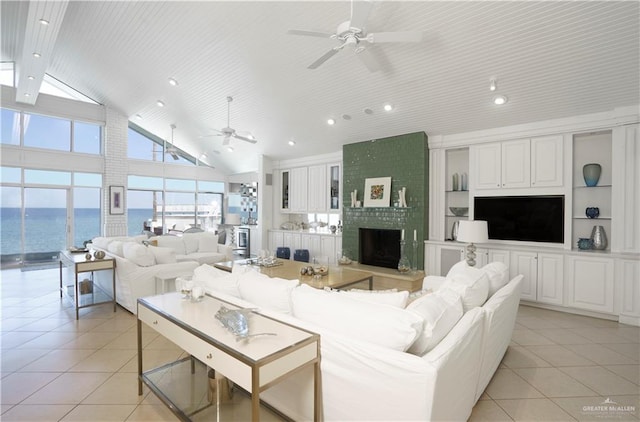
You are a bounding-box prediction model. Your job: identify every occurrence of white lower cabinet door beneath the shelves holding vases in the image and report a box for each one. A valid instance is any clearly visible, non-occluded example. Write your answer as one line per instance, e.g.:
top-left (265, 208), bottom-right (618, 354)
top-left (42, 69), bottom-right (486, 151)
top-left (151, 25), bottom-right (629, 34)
top-left (566, 253), bottom-right (616, 313)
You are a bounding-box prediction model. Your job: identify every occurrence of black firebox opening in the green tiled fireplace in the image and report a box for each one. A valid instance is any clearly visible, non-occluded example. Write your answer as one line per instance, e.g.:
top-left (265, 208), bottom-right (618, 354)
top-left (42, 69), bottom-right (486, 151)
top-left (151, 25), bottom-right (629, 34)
top-left (358, 227), bottom-right (400, 268)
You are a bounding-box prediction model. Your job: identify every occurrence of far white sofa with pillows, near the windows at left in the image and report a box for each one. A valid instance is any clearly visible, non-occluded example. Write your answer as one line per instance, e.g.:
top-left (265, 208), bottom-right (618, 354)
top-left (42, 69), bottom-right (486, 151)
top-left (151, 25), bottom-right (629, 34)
top-left (91, 233), bottom-right (232, 313)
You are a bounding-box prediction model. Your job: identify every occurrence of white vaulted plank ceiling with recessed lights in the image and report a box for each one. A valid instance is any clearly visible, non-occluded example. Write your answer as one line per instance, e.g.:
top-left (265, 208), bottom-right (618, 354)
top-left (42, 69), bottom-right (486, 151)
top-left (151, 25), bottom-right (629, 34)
top-left (1, 0), bottom-right (640, 173)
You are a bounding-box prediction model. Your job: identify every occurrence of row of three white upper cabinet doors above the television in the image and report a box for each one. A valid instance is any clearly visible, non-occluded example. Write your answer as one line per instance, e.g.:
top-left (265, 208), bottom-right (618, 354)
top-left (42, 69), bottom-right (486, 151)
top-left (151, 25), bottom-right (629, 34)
top-left (471, 136), bottom-right (563, 189)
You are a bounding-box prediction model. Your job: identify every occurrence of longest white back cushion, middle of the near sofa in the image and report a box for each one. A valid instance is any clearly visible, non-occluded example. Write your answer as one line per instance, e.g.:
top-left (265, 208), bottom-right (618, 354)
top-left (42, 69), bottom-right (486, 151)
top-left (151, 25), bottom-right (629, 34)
top-left (291, 284), bottom-right (423, 351)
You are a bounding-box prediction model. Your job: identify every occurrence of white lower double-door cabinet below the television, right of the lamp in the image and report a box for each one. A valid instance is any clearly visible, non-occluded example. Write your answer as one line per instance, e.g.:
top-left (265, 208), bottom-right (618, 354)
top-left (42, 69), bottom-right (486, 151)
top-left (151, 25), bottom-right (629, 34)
top-left (509, 251), bottom-right (564, 305)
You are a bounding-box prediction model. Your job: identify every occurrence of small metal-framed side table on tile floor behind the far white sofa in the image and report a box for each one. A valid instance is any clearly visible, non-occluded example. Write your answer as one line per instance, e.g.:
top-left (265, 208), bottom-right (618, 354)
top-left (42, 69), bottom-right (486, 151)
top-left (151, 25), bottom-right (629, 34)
top-left (59, 250), bottom-right (116, 319)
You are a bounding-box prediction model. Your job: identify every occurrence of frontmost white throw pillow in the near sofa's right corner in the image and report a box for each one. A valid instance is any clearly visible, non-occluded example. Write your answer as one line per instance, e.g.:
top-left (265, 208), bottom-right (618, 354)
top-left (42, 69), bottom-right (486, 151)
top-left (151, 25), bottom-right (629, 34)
top-left (407, 289), bottom-right (464, 356)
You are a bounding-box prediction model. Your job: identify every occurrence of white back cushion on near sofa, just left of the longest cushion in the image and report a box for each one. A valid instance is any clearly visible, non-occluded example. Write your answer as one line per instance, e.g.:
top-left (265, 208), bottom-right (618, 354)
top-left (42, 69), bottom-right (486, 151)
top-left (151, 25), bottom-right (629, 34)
top-left (238, 271), bottom-right (300, 314)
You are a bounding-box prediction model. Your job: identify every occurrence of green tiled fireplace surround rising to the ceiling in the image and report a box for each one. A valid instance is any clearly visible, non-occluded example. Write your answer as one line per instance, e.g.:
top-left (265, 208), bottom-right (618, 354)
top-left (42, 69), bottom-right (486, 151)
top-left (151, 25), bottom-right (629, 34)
top-left (342, 132), bottom-right (429, 269)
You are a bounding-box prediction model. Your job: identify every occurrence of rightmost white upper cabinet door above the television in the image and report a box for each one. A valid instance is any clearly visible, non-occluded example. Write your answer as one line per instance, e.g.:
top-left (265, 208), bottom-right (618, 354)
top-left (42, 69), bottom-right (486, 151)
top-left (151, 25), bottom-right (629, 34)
top-left (531, 136), bottom-right (563, 187)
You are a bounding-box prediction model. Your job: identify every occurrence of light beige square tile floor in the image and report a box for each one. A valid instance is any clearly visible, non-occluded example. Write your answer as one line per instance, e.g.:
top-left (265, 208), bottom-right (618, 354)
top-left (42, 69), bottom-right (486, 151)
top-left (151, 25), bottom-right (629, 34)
top-left (0, 269), bottom-right (640, 421)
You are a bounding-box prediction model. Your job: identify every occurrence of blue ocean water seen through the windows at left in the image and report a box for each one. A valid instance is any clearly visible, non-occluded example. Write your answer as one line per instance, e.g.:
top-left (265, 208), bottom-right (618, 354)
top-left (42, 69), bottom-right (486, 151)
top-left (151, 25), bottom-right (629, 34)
top-left (0, 207), bottom-right (152, 257)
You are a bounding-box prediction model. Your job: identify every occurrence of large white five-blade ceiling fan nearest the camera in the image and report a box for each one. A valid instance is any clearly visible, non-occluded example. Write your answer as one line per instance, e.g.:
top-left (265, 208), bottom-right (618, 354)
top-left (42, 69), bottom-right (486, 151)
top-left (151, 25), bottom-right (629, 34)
top-left (287, 0), bottom-right (423, 72)
